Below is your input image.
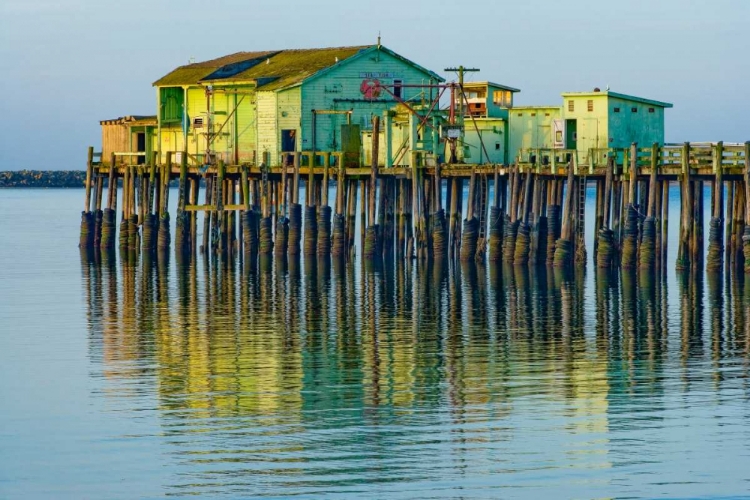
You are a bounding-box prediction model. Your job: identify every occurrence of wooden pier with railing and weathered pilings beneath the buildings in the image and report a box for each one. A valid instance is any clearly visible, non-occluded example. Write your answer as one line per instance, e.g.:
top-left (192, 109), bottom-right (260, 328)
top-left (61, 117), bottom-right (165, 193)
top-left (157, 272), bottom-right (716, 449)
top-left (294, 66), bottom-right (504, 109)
top-left (80, 139), bottom-right (750, 273)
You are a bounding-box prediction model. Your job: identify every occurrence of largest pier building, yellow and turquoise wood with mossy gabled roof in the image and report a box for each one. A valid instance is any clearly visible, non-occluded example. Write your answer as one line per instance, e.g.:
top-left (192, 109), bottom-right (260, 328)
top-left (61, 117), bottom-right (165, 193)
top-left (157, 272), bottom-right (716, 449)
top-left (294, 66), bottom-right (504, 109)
top-left (154, 44), bottom-right (442, 165)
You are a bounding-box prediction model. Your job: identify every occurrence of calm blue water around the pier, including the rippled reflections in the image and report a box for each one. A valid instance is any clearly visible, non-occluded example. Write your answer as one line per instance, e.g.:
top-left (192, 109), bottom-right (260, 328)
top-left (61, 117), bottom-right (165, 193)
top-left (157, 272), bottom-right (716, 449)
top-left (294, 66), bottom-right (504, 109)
top-left (0, 190), bottom-right (750, 498)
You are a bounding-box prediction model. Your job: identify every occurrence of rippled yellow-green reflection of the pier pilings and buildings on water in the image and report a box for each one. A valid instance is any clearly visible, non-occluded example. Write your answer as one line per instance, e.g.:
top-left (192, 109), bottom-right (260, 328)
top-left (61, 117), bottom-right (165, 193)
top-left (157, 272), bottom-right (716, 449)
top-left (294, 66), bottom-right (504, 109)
top-left (82, 253), bottom-right (750, 495)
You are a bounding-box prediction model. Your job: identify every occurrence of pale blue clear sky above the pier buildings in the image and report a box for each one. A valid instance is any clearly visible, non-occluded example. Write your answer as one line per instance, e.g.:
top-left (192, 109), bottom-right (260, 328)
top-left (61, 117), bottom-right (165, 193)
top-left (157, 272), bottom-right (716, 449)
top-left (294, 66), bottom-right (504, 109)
top-left (0, 0), bottom-right (750, 170)
